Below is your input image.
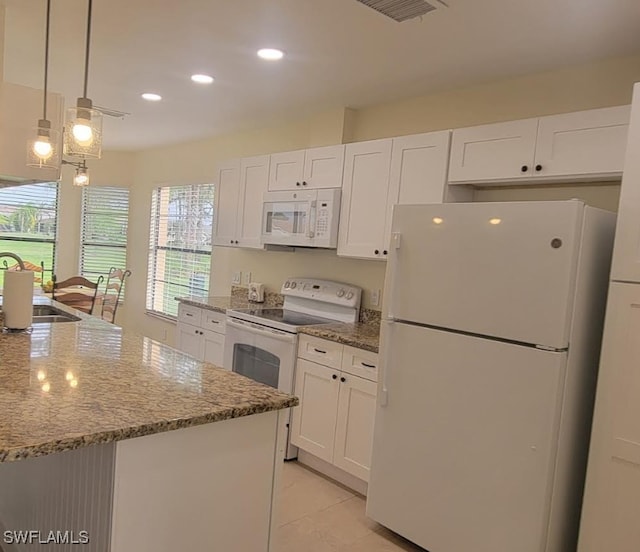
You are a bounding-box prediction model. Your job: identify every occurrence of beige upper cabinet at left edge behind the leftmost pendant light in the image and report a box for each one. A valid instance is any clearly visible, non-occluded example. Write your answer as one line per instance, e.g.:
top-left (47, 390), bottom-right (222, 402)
top-left (0, 82), bottom-right (64, 182)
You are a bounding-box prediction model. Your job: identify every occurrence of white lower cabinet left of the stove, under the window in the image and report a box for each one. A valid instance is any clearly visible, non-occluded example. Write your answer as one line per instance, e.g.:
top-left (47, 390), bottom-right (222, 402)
top-left (176, 303), bottom-right (225, 367)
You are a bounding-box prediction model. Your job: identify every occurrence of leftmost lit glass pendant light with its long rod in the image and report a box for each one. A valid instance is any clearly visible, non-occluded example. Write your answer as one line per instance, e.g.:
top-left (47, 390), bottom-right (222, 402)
top-left (27, 0), bottom-right (60, 169)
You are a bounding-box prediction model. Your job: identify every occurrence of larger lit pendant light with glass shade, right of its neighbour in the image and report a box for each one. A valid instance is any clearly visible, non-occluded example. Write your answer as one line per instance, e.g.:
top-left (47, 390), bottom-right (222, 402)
top-left (64, 0), bottom-right (102, 159)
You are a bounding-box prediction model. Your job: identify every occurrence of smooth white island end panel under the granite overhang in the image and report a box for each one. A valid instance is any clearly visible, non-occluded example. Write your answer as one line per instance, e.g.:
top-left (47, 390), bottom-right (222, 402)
top-left (111, 411), bottom-right (283, 552)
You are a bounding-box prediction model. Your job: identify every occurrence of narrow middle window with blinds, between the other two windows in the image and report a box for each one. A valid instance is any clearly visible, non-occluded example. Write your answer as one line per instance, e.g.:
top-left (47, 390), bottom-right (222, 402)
top-left (80, 186), bottom-right (129, 282)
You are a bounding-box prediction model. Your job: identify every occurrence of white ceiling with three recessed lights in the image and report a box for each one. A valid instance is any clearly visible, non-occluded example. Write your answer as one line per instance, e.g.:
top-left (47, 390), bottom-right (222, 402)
top-left (0, 0), bottom-right (640, 149)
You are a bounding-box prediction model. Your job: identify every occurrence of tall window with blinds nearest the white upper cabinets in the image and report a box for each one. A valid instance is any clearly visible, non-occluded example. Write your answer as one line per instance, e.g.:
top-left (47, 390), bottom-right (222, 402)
top-left (147, 184), bottom-right (213, 317)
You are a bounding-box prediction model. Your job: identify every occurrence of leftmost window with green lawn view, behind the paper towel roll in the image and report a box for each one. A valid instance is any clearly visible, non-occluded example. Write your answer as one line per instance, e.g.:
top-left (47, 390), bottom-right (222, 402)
top-left (0, 182), bottom-right (58, 287)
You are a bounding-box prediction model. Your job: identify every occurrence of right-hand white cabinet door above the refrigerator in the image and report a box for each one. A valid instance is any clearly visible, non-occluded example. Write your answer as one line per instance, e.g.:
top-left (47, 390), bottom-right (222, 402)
top-left (533, 106), bottom-right (630, 178)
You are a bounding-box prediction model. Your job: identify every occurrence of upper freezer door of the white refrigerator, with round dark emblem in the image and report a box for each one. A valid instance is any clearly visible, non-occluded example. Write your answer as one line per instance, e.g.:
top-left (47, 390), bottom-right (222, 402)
top-left (385, 201), bottom-right (584, 348)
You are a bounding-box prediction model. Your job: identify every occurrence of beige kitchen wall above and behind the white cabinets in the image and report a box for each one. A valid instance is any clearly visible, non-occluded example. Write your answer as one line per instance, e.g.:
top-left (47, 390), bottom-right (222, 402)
top-left (56, 56), bottom-right (640, 343)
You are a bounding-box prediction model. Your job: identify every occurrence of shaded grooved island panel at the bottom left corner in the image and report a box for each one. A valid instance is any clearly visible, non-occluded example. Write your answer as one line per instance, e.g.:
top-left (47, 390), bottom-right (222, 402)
top-left (0, 443), bottom-right (115, 552)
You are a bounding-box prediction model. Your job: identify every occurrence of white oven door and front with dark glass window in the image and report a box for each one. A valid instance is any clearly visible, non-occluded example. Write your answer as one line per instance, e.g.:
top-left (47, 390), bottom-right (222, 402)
top-left (224, 317), bottom-right (298, 460)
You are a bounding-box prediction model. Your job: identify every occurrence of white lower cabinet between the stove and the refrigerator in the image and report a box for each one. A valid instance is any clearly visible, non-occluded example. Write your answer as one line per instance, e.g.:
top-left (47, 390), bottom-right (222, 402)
top-left (291, 335), bottom-right (378, 481)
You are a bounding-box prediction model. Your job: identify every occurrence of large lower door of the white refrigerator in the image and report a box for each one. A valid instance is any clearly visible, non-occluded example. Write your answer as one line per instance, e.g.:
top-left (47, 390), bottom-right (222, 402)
top-left (367, 323), bottom-right (577, 552)
